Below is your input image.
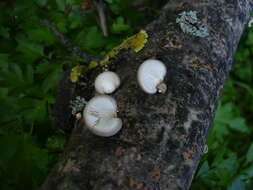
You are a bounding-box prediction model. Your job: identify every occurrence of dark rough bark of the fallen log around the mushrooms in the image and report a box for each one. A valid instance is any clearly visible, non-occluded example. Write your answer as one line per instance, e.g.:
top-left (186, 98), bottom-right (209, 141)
top-left (42, 0), bottom-right (253, 190)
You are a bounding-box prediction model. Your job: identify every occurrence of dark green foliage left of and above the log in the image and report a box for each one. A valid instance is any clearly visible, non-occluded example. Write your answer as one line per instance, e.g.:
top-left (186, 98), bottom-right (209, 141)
top-left (0, 0), bottom-right (145, 190)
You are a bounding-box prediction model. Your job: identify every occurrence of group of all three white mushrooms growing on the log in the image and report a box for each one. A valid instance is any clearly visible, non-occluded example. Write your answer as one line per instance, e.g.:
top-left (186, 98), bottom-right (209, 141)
top-left (79, 59), bottom-right (167, 137)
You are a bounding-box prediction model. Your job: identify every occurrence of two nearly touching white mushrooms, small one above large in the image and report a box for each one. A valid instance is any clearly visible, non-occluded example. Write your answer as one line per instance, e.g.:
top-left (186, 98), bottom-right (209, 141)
top-left (83, 71), bottom-right (122, 137)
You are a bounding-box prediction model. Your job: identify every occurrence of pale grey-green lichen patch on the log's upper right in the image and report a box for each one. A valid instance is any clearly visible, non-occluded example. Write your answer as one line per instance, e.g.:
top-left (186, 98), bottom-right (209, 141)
top-left (176, 11), bottom-right (209, 38)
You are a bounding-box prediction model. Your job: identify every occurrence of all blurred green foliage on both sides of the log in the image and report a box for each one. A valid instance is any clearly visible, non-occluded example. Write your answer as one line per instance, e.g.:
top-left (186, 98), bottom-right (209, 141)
top-left (0, 0), bottom-right (253, 190)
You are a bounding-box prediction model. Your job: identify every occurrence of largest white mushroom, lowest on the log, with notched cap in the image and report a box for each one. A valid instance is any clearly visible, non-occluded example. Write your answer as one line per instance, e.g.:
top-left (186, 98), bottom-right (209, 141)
top-left (83, 95), bottom-right (122, 137)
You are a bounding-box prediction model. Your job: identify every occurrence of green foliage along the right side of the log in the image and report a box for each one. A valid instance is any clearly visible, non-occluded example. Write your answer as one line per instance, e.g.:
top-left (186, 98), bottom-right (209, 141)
top-left (191, 29), bottom-right (253, 190)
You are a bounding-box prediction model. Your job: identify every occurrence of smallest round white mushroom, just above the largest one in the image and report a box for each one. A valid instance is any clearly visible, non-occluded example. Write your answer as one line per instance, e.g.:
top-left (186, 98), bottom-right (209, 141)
top-left (95, 71), bottom-right (120, 94)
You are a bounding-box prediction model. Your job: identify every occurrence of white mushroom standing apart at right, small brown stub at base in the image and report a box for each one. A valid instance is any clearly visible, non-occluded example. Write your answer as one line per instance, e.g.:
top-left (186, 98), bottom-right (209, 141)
top-left (137, 59), bottom-right (167, 94)
